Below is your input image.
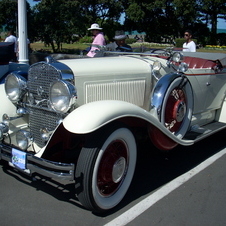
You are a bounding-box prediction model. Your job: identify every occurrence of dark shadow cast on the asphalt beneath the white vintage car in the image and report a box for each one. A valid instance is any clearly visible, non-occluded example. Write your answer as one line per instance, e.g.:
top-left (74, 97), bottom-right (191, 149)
top-left (0, 130), bottom-right (226, 217)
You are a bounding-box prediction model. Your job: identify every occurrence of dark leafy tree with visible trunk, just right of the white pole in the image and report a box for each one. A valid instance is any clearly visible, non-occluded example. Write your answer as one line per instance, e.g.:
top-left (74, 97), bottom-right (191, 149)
top-left (33, 0), bottom-right (80, 52)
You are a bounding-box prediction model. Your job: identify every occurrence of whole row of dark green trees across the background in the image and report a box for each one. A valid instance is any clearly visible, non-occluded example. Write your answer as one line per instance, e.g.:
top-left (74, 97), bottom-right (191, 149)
top-left (0, 0), bottom-right (222, 49)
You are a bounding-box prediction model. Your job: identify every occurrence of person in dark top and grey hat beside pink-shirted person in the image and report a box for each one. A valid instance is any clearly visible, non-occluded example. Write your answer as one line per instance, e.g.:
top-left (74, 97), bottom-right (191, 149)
top-left (107, 31), bottom-right (133, 52)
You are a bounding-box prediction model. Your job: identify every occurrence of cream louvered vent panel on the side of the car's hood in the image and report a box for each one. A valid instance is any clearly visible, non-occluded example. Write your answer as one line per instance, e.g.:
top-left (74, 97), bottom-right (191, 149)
top-left (86, 79), bottom-right (145, 106)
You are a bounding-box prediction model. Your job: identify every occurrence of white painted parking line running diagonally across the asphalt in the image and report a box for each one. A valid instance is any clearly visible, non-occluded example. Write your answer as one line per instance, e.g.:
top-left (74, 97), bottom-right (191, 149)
top-left (105, 148), bottom-right (226, 226)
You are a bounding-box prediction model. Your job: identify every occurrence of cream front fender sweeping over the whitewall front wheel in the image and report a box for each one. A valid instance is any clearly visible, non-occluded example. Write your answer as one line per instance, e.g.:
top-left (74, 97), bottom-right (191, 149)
top-left (63, 100), bottom-right (193, 145)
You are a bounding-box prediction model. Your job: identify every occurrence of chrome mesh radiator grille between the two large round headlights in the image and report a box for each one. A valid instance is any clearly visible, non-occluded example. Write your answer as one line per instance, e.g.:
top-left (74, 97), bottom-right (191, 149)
top-left (27, 62), bottom-right (61, 147)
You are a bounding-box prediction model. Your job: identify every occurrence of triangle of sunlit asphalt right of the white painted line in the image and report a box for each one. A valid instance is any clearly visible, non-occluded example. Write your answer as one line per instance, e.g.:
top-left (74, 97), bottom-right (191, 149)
top-left (128, 155), bottom-right (226, 226)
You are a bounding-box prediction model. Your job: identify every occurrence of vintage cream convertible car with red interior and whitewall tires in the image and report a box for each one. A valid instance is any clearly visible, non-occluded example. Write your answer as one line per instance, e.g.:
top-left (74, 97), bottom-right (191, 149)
top-left (0, 46), bottom-right (226, 212)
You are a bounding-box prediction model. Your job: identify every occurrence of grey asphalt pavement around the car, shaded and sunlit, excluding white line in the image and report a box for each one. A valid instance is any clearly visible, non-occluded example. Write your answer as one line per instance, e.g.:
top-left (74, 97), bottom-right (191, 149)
top-left (0, 130), bottom-right (226, 226)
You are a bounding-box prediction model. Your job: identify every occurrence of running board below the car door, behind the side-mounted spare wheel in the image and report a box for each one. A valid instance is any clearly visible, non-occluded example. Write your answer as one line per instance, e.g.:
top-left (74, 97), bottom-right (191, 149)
top-left (182, 122), bottom-right (226, 142)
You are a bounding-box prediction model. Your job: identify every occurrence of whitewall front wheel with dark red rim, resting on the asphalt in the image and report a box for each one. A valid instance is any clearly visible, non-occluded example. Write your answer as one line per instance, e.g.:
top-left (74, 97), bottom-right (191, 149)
top-left (75, 127), bottom-right (137, 212)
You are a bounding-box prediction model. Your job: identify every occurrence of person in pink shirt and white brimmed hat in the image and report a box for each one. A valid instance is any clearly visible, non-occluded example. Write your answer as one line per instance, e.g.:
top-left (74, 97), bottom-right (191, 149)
top-left (87, 23), bottom-right (106, 57)
